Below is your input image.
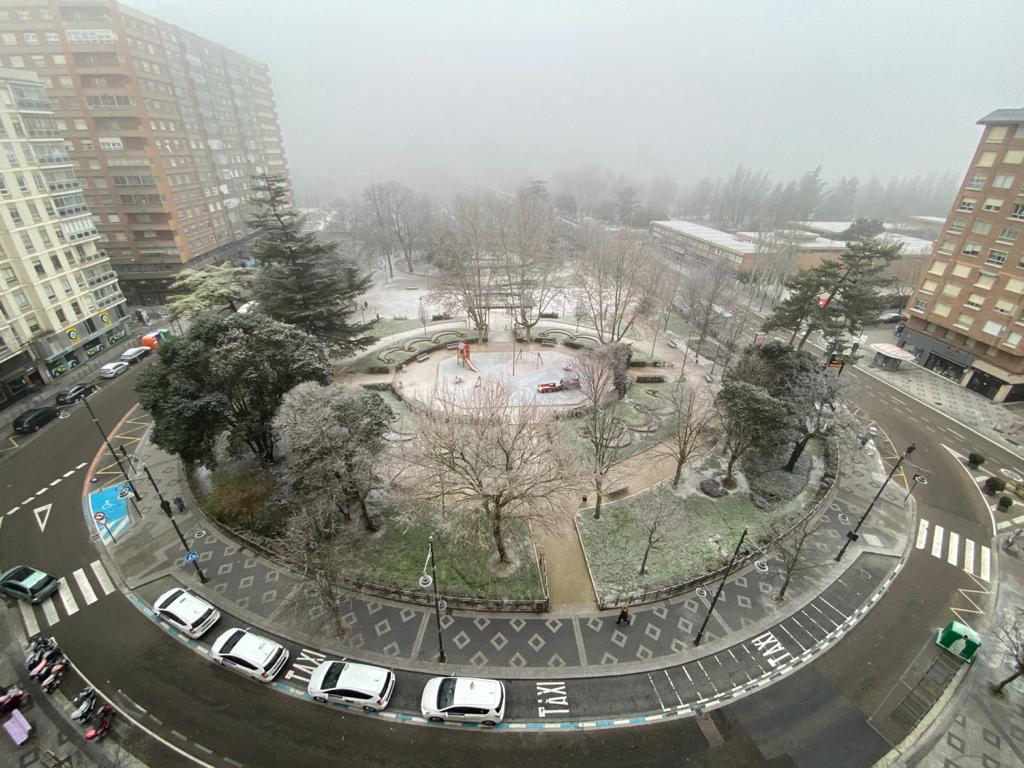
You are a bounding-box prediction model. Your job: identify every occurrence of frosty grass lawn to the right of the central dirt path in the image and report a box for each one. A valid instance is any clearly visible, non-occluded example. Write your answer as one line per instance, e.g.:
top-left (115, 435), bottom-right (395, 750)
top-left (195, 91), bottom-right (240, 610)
top-left (577, 441), bottom-right (822, 594)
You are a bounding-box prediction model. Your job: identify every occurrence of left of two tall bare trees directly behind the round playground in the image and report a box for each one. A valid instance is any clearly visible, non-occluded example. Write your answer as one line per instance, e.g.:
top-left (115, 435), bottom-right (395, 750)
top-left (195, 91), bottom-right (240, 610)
top-left (433, 195), bottom-right (504, 342)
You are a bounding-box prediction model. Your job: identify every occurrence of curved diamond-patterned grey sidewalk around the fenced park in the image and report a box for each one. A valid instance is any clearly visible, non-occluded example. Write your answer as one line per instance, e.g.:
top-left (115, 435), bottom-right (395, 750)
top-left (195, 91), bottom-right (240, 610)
top-left (90, 411), bottom-right (912, 678)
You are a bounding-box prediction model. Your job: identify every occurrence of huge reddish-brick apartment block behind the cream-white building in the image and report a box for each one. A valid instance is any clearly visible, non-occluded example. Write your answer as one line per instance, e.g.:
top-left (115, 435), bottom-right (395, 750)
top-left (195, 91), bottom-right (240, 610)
top-left (0, 0), bottom-right (288, 304)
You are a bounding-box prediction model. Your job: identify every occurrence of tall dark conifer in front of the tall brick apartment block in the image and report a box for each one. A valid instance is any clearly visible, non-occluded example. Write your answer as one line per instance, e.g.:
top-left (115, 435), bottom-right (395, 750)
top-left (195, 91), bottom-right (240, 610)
top-left (249, 174), bottom-right (372, 354)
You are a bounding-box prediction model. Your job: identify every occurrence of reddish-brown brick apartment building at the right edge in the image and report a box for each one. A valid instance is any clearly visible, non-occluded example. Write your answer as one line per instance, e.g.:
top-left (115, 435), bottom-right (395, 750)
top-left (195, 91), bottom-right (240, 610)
top-left (900, 109), bottom-right (1024, 402)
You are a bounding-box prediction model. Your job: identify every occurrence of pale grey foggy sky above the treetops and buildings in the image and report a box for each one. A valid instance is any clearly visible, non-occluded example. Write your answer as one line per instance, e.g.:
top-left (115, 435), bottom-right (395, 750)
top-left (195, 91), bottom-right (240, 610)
top-left (127, 0), bottom-right (1024, 202)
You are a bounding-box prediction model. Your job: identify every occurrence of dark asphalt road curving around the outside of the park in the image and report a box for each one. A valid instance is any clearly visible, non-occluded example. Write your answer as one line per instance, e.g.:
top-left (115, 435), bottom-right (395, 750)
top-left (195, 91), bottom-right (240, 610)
top-left (0, 346), bottom-right (1007, 767)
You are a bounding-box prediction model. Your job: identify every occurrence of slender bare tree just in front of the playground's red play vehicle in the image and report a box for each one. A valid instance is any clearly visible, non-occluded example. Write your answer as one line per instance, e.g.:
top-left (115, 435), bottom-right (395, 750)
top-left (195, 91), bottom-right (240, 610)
top-left (572, 347), bottom-right (627, 520)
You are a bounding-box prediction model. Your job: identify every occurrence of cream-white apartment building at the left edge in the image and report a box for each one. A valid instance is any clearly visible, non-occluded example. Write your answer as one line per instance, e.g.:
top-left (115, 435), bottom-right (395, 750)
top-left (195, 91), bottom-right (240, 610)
top-left (0, 69), bottom-right (128, 408)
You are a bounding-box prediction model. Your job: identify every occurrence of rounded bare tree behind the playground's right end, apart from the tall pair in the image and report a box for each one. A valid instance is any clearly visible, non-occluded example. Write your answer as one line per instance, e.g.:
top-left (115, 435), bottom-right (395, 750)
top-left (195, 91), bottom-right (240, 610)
top-left (577, 226), bottom-right (659, 342)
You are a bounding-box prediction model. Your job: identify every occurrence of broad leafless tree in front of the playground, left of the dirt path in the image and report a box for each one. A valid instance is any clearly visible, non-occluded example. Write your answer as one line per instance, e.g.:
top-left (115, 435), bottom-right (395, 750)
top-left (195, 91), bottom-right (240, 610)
top-left (404, 380), bottom-right (579, 564)
